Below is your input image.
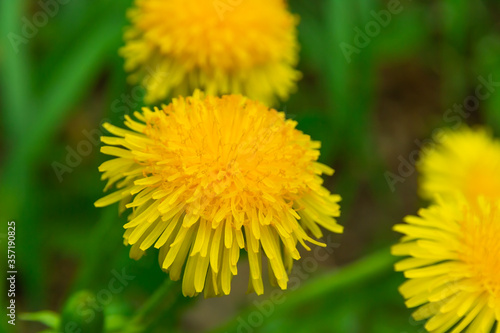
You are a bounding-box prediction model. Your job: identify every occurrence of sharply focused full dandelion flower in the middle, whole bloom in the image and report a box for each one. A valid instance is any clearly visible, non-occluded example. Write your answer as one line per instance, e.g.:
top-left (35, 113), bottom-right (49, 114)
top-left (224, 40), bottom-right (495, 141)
top-left (95, 92), bottom-right (342, 296)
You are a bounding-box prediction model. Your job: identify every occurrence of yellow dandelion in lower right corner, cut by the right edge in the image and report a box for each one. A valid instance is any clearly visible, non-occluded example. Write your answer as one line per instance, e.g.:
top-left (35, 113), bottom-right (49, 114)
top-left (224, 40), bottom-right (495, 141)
top-left (392, 197), bottom-right (500, 333)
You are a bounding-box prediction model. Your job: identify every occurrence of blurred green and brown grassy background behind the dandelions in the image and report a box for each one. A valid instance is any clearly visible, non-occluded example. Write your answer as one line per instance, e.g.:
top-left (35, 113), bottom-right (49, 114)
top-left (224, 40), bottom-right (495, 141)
top-left (0, 0), bottom-right (500, 333)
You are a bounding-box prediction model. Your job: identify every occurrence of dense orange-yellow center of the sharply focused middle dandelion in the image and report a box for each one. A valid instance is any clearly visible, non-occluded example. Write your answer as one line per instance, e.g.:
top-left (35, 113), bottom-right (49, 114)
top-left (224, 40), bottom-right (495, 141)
top-left (142, 96), bottom-right (319, 219)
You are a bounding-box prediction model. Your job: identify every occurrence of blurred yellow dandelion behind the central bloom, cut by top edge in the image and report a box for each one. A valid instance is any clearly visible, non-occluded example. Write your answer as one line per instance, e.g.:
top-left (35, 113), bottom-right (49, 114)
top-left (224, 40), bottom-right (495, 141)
top-left (120, 0), bottom-right (301, 105)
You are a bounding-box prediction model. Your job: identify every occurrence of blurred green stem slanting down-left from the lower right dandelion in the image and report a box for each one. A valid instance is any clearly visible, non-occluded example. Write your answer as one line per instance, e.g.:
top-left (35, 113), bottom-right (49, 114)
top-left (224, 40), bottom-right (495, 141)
top-left (211, 248), bottom-right (396, 333)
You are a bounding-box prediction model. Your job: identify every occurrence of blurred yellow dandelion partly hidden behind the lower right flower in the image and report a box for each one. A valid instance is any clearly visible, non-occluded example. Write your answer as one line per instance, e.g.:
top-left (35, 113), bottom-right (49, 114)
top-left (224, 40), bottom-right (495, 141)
top-left (417, 128), bottom-right (500, 199)
